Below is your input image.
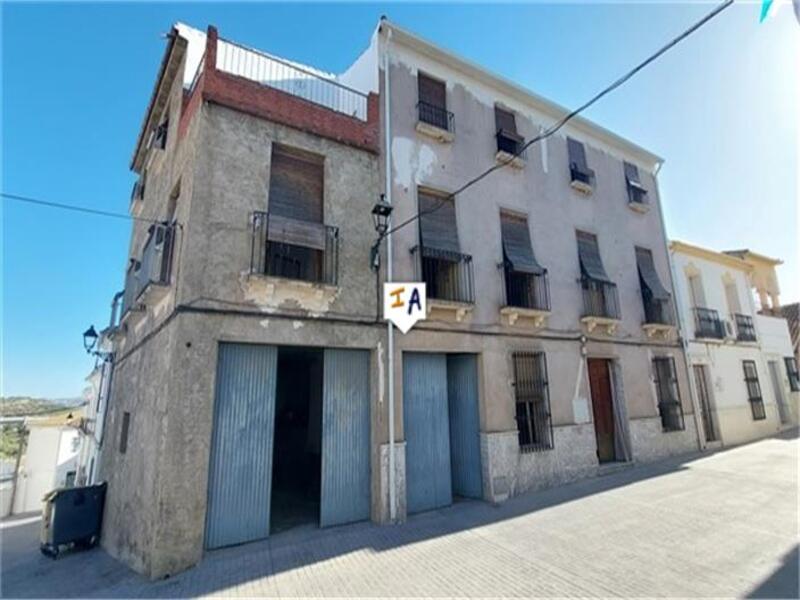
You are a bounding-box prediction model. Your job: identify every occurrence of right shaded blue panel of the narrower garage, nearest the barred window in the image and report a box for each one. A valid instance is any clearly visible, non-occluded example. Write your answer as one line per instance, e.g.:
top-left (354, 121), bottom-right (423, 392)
top-left (447, 354), bottom-right (483, 498)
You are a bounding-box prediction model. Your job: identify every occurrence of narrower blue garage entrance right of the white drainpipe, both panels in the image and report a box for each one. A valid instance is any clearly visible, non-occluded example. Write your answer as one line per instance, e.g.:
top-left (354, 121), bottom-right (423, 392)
top-left (403, 352), bottom-right (483, 513)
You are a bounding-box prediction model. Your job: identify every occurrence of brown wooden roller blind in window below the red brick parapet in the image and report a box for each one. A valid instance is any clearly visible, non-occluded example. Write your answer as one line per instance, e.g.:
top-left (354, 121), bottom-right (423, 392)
top-left (269, 147), bottom-right (323, 223)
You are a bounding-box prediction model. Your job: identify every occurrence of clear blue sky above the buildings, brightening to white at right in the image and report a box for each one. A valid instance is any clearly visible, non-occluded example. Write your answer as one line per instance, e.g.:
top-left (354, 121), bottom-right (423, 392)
top-left (0, 1), bottom-right (800, 398)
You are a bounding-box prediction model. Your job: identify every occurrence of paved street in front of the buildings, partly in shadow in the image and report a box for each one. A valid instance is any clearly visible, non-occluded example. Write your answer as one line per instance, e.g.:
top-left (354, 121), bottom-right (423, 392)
top-left (0, 436), bottom-right (800, 598)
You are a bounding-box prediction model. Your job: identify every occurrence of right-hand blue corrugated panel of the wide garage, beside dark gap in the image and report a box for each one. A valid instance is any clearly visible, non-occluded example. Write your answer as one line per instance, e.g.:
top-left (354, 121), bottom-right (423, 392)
top-left (319, 348), bottom-right (370, 527)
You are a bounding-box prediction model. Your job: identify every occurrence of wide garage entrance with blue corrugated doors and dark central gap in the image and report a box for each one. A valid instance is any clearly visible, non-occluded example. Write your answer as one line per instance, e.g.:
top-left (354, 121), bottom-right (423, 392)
top-left (206, 343), bottom-right (370, 548)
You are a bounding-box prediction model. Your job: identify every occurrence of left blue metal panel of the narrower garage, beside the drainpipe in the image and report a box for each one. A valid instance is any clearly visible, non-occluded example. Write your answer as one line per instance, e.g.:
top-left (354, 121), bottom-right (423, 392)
top-left (403, 352), bottom-right (453, 513)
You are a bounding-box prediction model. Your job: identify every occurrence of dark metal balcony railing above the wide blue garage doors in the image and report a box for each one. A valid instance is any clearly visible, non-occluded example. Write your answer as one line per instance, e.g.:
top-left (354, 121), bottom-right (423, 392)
top-left (250, 212), bottom-right (339, 285)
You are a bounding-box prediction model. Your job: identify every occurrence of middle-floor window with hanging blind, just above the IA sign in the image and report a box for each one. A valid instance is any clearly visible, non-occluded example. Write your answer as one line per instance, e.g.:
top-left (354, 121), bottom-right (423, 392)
top-left (412, 190), bottom-right (474, 303)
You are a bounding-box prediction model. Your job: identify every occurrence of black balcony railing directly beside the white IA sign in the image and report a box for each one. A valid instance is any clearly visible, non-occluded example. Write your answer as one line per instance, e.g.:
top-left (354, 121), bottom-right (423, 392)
top-left (411, 246), bottom-right (475, 304)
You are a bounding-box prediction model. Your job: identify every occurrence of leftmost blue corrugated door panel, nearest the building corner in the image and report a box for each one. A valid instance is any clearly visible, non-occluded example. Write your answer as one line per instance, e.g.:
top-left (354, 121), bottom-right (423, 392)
top-left (206, 344), bottom-right (278, 548)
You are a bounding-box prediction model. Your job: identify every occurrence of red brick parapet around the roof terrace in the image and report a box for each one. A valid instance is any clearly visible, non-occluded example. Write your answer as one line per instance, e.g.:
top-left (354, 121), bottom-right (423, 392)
top-left (178, 27), bottom-right (380, 154)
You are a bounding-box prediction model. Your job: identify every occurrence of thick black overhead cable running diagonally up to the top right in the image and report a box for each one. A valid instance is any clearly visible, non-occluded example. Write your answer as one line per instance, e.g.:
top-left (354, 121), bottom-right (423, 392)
top-left (378, 0), bottom-right (733, 242)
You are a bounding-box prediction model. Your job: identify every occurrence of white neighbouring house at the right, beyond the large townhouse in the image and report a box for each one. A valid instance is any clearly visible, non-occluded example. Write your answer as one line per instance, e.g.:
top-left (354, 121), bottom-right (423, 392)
top-left (670, 241), bottom-right (796, 445)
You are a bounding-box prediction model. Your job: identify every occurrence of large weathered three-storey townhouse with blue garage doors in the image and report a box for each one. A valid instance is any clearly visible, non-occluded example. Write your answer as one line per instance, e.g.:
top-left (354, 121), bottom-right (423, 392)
top-left (97, 20), bottom-right (700, 577)
